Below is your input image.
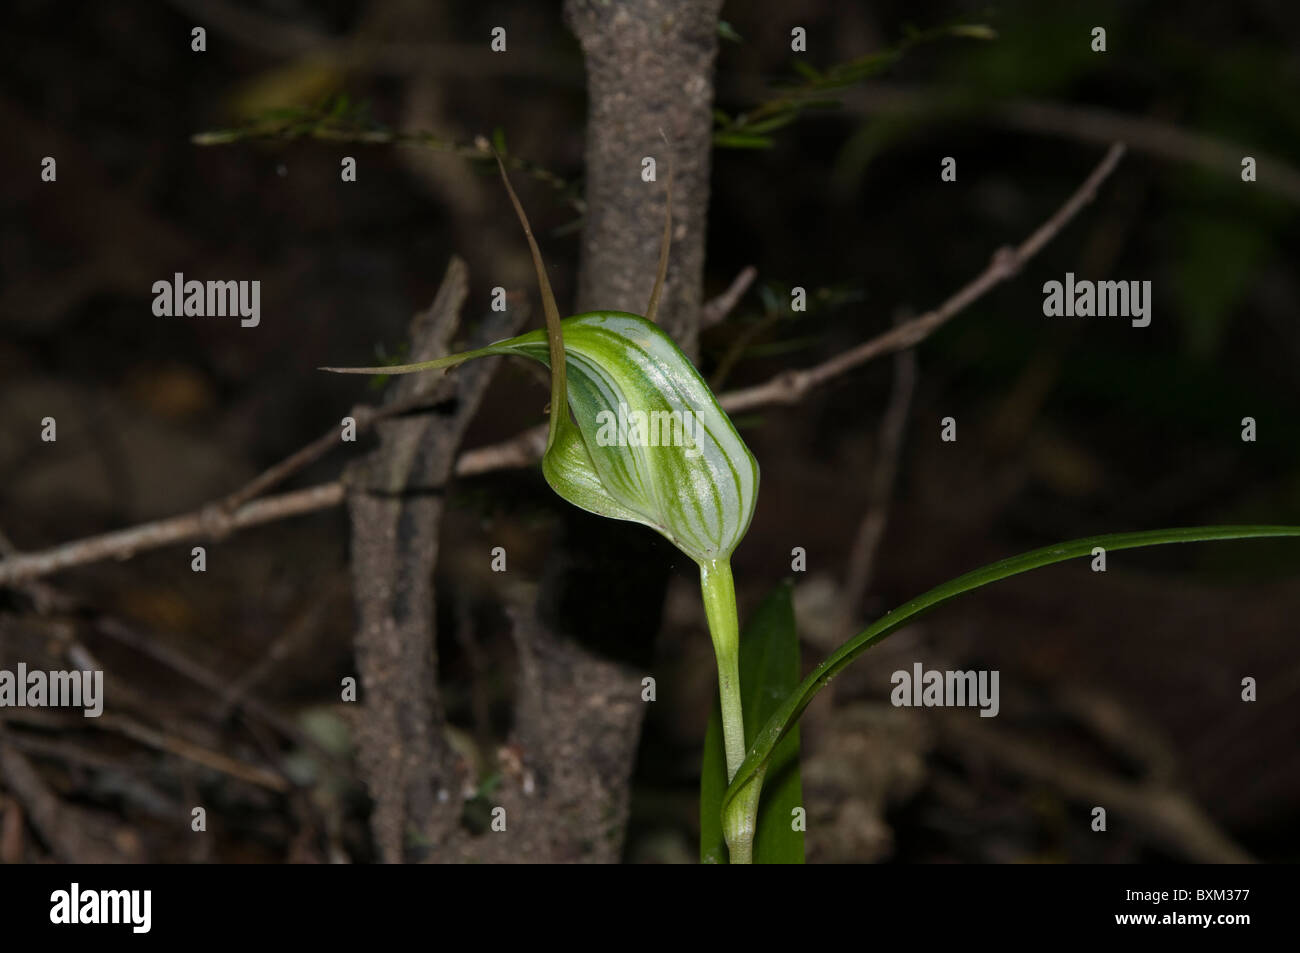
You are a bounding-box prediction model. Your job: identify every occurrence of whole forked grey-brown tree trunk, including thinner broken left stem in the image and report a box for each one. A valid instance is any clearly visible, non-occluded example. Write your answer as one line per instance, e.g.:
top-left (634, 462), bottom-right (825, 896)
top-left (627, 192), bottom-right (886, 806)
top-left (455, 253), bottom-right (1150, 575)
top-left (350, 0), bottom-right (720, 862)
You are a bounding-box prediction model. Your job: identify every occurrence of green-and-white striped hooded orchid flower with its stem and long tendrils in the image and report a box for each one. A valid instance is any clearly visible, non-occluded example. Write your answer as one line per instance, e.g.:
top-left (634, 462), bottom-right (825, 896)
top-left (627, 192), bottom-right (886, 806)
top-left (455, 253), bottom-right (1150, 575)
top-left (322, 148), bottom-right (758, 863)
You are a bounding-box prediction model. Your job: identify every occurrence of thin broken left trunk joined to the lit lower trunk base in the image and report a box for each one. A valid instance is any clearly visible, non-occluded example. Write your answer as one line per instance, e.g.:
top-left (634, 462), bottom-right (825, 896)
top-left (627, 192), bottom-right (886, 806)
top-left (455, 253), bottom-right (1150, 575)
top-left (347, 259), bottom-right (642, 863)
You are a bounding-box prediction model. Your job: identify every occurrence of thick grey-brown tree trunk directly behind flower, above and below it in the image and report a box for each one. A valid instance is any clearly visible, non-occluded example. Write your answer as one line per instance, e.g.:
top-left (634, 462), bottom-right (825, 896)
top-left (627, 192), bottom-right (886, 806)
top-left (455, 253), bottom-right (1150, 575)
top-left (483, 0), bottom-right (722, 862)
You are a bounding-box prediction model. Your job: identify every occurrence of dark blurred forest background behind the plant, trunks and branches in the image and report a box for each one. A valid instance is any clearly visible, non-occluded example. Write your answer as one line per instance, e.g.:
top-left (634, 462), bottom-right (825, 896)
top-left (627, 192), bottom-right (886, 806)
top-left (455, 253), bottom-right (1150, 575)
top-left (0, 0), bottom-right (1300, 862)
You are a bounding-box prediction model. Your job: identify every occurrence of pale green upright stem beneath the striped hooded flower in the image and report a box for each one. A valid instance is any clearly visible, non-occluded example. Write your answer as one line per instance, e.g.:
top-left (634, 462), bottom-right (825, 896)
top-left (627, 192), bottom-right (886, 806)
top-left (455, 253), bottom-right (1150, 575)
top-left (699, 559), bottom-right (759, 863)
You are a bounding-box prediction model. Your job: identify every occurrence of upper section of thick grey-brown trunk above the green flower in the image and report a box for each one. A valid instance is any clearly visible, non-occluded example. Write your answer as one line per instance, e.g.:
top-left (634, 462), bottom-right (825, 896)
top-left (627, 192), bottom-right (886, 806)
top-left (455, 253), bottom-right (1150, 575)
top-left (564, 0), bottom-right (722, 359)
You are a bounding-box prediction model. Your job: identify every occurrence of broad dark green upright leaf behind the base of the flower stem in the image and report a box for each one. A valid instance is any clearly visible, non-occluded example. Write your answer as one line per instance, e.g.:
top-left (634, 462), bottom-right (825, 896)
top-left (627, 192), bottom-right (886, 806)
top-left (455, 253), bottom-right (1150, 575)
top-left (699, 582), bottom-right (803, 863)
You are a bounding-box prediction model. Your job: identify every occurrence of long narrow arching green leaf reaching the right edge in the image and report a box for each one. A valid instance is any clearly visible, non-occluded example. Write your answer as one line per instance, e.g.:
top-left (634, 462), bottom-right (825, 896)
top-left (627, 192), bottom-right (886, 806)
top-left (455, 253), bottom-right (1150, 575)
top-left (723, 527), bottom-right (1300, 832)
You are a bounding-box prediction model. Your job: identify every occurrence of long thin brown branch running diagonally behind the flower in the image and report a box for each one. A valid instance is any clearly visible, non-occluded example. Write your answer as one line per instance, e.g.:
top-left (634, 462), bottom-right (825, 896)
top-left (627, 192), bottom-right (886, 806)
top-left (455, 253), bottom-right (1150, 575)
top-left (0, 143), bottom-right (1125, 585)
